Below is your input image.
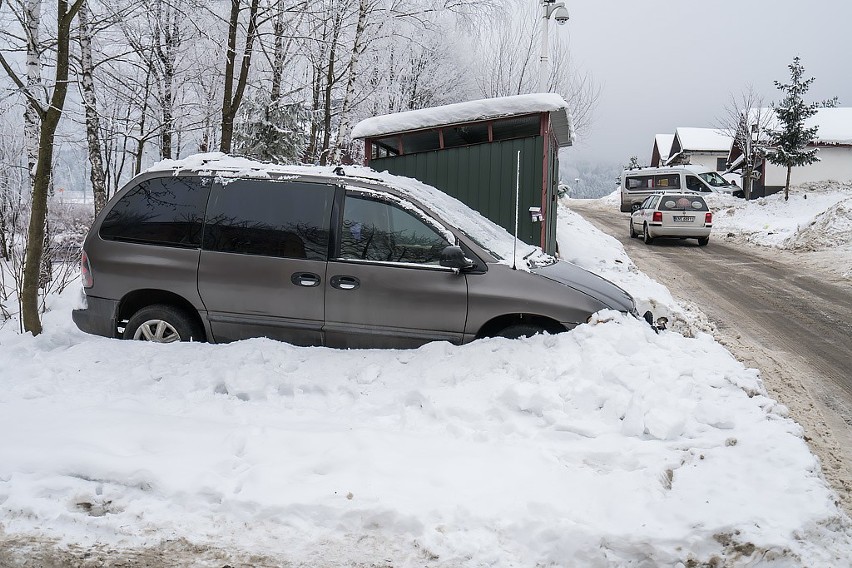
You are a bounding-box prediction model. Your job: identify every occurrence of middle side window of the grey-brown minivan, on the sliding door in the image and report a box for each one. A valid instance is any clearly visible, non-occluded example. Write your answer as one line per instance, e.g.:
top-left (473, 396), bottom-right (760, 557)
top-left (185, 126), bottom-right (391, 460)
top-left (204, 179), bottom-right (334, 260)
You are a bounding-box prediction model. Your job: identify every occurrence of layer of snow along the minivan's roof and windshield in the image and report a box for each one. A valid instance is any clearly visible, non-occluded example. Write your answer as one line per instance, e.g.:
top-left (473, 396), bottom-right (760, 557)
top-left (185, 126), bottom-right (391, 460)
top-left (146, 152), bottom-right (553, 269)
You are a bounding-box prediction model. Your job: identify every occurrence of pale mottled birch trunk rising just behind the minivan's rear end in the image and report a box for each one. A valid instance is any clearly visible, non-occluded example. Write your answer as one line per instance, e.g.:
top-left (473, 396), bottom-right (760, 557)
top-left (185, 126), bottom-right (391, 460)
top-left (78, 4), bottom-right (107, 216)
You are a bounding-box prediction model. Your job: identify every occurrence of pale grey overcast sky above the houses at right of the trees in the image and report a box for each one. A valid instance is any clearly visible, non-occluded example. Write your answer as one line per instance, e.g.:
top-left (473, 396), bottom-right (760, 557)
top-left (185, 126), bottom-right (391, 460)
top-left (560, 0), bottom-right (852, 163)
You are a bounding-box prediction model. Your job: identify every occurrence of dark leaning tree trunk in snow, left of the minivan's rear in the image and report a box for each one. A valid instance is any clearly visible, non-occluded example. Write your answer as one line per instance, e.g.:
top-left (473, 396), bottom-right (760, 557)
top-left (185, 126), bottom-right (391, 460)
top-left (21, 0), bottom-right (84, 335)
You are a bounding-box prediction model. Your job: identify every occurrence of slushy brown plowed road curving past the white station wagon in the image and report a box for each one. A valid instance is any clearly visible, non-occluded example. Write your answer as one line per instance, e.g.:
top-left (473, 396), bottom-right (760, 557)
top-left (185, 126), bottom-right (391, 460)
top-left (569, 200), bottom-right (852, 511)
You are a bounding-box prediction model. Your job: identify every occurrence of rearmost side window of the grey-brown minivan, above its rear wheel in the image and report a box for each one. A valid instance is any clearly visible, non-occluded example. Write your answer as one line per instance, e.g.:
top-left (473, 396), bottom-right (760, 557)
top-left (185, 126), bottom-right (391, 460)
top-left (99, 176), bottom-right (211, 248)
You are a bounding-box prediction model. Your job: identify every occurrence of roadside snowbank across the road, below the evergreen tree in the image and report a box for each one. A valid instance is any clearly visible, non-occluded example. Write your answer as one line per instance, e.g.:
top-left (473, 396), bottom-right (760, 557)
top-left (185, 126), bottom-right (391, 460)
top-left (707, 182), bottom-right (852, 250)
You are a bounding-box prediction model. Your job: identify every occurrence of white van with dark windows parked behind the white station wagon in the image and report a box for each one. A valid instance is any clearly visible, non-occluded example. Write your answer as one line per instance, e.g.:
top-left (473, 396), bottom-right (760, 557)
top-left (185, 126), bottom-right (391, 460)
top-left (621, 165), bottom-right (739, 213)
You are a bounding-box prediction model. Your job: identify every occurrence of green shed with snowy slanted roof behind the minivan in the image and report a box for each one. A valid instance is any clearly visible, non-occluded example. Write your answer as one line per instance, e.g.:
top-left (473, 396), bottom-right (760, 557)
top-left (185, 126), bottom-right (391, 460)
top-left (352, 93), bottom-right (574, 254)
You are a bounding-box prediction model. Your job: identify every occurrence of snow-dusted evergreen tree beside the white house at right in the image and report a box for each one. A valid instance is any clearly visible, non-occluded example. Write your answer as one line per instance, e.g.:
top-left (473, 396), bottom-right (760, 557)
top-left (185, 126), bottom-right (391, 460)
top-left (766, 57), bottom-right (837, 201)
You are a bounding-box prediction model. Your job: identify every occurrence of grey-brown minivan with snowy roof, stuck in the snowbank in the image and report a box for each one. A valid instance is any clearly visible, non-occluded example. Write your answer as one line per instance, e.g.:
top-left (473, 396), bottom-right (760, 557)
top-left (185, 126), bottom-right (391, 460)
top-left (73, 154), bottom-right (636, 348)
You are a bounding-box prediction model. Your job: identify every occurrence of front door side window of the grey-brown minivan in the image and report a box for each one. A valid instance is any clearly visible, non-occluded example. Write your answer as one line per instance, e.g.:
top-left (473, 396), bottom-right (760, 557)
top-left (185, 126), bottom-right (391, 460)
top-left (340, 193), bottom-right (450, 265)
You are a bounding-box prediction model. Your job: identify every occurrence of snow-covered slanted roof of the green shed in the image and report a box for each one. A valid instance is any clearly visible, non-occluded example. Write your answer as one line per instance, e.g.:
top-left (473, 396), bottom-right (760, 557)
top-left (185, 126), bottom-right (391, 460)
top-left (352, 93), bottom-right (576, 146)
